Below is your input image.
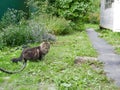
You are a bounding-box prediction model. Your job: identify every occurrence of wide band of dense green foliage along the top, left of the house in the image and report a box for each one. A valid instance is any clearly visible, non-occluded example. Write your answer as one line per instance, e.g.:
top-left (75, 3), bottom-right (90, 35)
top-left (28, 0), bottom-right (100, 24)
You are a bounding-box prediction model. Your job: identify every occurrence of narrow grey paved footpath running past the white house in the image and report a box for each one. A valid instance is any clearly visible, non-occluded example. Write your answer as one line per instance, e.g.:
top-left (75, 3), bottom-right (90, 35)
top-left (86, 29), bottom-right (120, 87)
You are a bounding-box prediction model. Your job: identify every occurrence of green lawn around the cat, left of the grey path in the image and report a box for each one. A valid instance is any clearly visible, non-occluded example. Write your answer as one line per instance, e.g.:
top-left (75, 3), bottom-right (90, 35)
top-left (0, 31), bottom-right (119, 90)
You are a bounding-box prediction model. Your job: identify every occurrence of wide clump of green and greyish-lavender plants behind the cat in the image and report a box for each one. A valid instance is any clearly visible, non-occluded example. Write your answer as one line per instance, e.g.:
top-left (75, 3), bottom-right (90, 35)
top-left (3, 21), bottom-right (46, 46)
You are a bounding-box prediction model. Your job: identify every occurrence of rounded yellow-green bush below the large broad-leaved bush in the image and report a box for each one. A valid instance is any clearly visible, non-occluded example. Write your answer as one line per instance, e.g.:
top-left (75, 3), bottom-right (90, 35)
top-left (47, 17), bottom-right (72, 35)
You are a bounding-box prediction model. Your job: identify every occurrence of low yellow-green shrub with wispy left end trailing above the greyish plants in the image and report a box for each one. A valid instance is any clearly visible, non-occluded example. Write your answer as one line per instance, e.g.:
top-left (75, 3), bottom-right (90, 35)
top-left (36, 14), bottom-right (72, 35)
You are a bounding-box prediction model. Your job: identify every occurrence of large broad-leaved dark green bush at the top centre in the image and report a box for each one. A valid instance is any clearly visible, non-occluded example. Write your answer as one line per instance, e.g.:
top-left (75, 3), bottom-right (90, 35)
top-left (55, 0), bottom-right (90, 22)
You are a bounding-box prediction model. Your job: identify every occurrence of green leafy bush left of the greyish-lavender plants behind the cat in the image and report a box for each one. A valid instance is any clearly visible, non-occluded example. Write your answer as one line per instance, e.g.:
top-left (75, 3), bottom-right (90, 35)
top-left (3, 26), bottom-right (29, 46)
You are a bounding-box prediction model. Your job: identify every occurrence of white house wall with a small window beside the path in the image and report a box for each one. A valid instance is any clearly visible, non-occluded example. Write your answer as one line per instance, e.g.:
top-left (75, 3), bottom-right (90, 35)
top-left (100, 0), bottom-right (120, 32)
